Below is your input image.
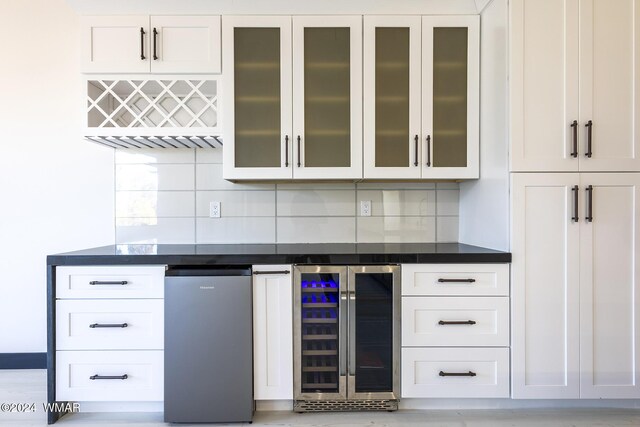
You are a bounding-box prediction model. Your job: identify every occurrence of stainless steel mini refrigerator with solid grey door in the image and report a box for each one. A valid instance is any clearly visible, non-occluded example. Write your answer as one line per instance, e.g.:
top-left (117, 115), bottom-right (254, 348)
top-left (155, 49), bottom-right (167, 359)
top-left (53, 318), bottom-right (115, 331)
top-left (164, 267), bottom-right (254, 423)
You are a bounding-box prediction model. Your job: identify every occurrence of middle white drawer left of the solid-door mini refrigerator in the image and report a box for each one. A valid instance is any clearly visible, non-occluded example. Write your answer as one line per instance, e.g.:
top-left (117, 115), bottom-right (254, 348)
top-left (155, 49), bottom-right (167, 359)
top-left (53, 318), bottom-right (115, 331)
top-left (56, 299), bottom-right (164, 350)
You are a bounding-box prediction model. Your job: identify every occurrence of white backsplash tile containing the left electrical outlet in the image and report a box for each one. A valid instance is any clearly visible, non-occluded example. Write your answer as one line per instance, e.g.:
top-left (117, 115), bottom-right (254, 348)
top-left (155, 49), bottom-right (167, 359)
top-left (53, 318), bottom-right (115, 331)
top-left (196, 191), bottom-right (276, 218)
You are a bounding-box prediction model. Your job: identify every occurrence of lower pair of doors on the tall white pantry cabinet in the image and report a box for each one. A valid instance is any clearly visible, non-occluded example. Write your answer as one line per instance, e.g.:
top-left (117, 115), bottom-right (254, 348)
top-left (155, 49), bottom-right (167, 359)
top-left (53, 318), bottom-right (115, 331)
top-left (511, 173), bottom-right (640, 399)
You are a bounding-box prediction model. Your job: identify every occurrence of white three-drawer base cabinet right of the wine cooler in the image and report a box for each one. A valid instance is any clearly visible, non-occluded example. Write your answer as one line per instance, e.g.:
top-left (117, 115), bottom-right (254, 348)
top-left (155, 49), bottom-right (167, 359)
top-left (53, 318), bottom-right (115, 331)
top-left (401, 264), bottom-right (509, 398)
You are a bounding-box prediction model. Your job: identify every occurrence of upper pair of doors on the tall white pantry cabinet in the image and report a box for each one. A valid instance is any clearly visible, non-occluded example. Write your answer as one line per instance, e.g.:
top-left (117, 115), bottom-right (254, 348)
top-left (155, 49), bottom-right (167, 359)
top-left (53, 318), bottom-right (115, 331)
top-left (509, 0), bottom-right (640, 171)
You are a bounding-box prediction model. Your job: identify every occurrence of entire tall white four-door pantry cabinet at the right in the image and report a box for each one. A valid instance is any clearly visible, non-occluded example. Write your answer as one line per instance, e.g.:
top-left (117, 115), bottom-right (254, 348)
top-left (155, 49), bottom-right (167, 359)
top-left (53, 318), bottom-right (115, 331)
top-left (509, 0), bottom-right (640, 399)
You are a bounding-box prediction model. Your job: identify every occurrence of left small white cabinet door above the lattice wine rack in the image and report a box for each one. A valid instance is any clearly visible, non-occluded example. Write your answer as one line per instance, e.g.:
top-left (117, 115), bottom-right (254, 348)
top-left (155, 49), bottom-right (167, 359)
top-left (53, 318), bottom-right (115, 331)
top-left (81, 15), bottom-right (151, 73)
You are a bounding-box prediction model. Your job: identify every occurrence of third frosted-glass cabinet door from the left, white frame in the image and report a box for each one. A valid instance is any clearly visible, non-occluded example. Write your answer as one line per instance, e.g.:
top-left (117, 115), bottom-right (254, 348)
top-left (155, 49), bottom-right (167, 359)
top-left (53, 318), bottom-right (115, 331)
top-left (364, 16), bottom-right (422, 179)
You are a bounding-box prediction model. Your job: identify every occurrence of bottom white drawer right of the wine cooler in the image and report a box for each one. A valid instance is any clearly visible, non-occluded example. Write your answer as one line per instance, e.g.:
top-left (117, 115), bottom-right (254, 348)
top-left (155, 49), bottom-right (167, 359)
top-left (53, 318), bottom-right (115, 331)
top-left (402, 348), bottom-right (509, 398)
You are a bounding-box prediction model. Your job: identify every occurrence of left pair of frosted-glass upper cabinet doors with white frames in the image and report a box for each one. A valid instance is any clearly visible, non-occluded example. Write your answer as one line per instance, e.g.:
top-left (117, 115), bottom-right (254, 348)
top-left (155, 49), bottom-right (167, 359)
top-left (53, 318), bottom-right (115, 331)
top-left (223, 16), bottom-right (362, 180)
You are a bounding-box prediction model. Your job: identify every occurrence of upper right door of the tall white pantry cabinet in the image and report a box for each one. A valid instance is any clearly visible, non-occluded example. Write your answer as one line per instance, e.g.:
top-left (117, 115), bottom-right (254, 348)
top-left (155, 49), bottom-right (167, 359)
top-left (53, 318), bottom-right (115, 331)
top-left (576, 0), bottom-right (640, 172)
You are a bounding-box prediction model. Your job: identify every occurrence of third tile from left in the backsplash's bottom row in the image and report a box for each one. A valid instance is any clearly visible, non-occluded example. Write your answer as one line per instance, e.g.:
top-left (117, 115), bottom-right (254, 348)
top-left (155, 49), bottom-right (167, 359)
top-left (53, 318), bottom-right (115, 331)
top-left (277, 216), bottom-right (356, 243)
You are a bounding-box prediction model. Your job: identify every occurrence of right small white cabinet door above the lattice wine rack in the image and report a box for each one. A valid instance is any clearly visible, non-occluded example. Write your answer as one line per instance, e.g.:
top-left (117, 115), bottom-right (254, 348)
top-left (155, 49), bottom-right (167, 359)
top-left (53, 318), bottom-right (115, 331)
top-left (149, 16), bottom-right (221, 73)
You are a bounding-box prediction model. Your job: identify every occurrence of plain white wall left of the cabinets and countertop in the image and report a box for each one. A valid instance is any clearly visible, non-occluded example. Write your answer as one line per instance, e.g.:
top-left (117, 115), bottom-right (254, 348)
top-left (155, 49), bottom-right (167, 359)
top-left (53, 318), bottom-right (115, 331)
top-left (0, 0), bottom-right (114, 353)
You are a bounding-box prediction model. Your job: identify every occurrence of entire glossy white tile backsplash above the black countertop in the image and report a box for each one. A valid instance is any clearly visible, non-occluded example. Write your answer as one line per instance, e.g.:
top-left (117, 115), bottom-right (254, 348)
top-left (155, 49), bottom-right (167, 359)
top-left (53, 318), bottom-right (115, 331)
top-left (115, 149), bottom-right (459, 244)
